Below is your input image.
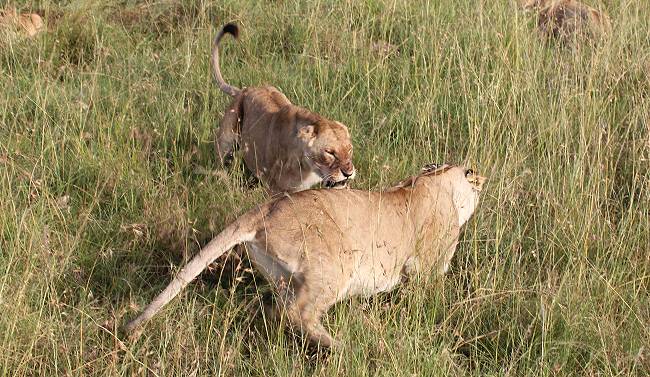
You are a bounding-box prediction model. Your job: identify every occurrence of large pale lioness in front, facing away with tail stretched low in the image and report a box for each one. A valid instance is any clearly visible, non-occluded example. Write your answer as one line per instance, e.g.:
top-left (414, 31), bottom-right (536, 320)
top-left (125, 165), bottom-right (485, 347)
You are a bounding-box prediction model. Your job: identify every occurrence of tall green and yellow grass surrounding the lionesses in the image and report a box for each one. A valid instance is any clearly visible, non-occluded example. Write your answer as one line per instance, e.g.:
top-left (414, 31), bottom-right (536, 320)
top-left (0, 0), bottom-right (650, 376)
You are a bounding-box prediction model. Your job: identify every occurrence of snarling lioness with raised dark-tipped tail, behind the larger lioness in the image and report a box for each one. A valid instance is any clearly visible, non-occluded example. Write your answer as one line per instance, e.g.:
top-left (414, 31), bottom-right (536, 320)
top-left (212, 24), bottom-right (355, 192)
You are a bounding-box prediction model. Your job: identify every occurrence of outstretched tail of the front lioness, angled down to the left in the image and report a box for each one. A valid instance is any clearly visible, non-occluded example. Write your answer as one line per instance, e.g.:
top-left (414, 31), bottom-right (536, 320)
top-left (124, 215), bottom-right (256, 333)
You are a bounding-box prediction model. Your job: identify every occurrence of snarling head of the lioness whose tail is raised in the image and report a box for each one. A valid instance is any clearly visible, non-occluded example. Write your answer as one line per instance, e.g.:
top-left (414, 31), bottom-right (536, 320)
top-left (299, 120), bottom-right (356, 187)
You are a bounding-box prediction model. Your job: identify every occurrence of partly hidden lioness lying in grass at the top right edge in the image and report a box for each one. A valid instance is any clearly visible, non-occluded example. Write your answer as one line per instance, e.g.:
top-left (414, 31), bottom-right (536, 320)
top-left (524, 0), bottom-right (612, 41)
